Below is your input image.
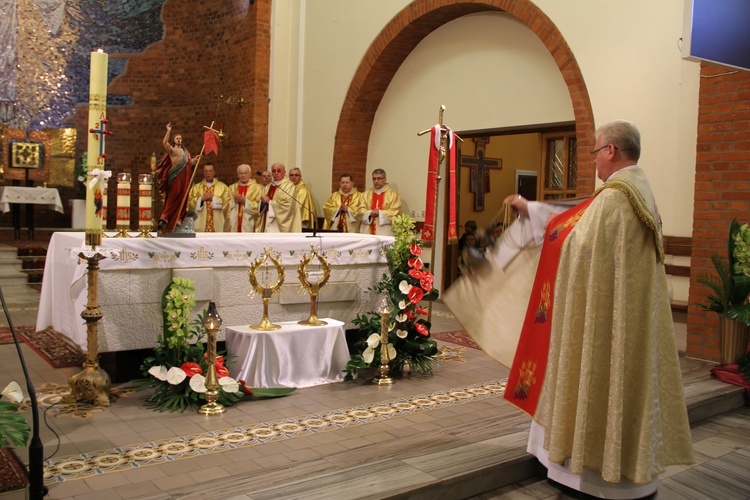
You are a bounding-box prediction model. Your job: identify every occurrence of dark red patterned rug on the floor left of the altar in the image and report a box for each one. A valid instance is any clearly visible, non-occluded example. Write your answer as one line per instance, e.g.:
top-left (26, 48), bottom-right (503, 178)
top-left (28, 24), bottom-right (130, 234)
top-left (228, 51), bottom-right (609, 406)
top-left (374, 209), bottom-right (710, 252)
top-left (0, 326), bottom-right (85, 368)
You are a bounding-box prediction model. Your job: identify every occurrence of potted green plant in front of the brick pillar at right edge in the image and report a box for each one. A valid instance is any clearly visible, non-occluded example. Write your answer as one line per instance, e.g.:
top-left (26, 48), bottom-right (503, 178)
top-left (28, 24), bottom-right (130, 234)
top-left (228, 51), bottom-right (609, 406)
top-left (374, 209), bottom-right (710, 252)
top-left (698, 219), bottom-right (750, 364)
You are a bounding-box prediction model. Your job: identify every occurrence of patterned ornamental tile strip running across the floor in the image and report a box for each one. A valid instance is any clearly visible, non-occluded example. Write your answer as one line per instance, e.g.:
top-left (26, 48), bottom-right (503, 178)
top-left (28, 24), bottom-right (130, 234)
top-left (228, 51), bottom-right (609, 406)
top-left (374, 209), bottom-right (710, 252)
top-left (44, 379), bottom-right (507, 484)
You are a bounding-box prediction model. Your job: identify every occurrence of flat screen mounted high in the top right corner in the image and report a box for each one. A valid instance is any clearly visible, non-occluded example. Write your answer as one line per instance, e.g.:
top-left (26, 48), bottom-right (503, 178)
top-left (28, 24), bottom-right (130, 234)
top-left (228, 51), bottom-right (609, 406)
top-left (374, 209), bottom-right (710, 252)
top-left (682, 0), bottom-right (750, 70)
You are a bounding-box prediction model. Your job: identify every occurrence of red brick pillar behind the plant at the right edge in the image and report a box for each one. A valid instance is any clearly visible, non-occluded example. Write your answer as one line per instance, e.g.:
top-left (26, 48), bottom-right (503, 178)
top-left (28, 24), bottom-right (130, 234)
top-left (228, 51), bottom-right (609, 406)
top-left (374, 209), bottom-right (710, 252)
top-left (687, 64), bottom-right (750, 360)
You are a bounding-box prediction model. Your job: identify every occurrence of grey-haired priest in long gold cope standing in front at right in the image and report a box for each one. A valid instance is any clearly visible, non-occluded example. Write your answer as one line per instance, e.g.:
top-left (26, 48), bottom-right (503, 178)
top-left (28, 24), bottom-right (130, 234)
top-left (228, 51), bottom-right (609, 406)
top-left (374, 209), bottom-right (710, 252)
top-left (444, 121), bottom-right (693, 498)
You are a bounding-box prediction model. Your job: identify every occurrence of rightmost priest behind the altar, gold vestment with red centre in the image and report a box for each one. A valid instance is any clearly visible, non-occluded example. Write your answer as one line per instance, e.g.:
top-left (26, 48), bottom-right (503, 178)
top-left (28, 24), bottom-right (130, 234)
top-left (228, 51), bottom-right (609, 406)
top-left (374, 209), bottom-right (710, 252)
top-left (357, 168), bottom-right (401, 236)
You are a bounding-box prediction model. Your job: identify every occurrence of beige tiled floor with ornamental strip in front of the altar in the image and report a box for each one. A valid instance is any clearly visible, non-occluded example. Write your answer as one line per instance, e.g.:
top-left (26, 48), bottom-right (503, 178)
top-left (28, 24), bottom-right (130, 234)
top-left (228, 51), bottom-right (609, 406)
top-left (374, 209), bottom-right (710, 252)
top-left (0, 274), bottom-right (750, 500)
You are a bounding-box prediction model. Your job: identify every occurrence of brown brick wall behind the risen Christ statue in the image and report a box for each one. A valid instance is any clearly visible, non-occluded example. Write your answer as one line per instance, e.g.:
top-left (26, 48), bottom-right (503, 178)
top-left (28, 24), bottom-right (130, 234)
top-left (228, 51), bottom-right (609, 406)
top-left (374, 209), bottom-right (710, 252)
top-left (75, 0), bottom-right (271, 228)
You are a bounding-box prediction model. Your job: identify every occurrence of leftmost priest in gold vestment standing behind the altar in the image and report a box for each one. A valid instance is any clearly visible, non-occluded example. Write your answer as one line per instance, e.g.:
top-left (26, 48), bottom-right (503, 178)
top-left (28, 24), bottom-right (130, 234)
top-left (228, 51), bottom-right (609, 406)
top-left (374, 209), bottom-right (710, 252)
top-left (188, 163), bottom-right (232, 233)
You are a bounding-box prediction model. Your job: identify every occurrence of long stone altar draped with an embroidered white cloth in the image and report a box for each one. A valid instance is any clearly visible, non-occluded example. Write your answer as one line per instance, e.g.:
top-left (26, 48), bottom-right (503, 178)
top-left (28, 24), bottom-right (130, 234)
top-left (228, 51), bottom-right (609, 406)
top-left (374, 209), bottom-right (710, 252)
top-left (36, 232), bottom-right (393, 353)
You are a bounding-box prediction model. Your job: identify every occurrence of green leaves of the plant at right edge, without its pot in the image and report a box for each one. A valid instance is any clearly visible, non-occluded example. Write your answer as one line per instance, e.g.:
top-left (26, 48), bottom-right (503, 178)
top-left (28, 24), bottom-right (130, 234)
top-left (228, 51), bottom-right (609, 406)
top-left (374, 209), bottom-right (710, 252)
top-left (697, 219), bottom-right (750, 325)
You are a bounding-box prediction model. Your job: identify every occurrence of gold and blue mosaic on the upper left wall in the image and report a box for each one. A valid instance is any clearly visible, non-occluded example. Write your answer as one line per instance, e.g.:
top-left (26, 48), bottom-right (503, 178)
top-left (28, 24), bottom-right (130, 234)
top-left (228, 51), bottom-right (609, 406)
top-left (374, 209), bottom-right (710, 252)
top-left (0, 0), bottom-right (165, 130)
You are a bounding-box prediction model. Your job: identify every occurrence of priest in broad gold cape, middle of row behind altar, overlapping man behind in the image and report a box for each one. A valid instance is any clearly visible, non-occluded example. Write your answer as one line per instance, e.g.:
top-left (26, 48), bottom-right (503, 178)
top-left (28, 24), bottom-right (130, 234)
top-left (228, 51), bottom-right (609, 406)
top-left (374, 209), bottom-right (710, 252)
top-left (255, 163), bottom-right (302, 233)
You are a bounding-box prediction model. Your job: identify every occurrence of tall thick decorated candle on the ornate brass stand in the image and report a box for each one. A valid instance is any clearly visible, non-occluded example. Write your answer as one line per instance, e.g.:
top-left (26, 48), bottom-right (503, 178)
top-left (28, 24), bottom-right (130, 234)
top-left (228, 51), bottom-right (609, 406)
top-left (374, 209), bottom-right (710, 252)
top-left (86, 50), bottom-right (109, 246)
